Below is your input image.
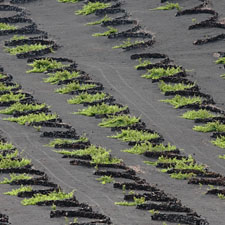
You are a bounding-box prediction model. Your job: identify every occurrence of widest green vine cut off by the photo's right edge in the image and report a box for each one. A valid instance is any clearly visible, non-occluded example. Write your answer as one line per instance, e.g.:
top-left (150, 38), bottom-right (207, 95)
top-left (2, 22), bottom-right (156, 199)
top-left (193, 121), bottom-right (225, 133)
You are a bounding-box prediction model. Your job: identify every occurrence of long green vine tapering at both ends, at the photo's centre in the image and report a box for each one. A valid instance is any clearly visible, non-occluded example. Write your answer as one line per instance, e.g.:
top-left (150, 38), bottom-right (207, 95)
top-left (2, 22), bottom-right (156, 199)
top-left (75, 103), bottom-right (127, 116)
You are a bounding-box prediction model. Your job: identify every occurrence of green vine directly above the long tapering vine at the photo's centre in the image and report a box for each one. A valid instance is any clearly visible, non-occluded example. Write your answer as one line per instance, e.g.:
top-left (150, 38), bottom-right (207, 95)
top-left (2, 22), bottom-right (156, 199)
top-left (67, 92), bottom-right (107, 104)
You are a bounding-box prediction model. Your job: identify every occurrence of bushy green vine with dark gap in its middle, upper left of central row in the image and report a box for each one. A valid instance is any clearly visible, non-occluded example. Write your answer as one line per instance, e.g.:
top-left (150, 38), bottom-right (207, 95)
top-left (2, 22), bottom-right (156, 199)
top-left (27, 58), bottom-right (65, 73)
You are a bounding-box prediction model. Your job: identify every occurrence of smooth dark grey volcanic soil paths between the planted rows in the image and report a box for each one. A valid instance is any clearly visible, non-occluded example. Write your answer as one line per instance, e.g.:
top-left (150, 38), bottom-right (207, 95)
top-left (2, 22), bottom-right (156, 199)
top-left (0, 0), bottom-right (225, 225)
